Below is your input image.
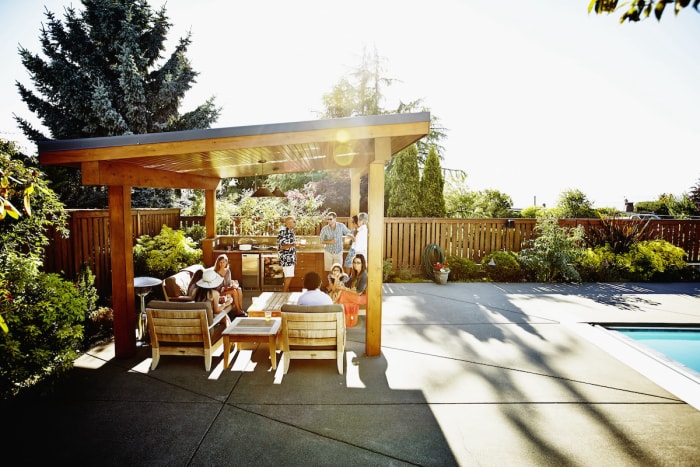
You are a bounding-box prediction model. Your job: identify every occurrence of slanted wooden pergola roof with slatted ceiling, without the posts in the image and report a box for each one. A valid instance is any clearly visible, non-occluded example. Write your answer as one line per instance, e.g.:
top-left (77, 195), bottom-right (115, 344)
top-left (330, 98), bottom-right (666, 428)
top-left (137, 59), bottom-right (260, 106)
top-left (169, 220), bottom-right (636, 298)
top-left (38, 112), bottom-right (430, 189)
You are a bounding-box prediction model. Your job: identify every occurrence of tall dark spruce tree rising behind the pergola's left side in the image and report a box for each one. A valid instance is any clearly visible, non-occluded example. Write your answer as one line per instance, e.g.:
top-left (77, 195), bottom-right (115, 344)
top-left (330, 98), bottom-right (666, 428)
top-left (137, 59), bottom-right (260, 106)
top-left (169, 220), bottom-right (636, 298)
top-left (15, 0), bottom-right (220, 207)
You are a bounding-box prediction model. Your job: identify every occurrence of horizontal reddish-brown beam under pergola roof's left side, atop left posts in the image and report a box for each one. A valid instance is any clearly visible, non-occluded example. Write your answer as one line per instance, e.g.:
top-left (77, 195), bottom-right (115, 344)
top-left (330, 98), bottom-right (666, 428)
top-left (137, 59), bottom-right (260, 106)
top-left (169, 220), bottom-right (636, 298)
top-left (81, 161), bottom-right (220, 190)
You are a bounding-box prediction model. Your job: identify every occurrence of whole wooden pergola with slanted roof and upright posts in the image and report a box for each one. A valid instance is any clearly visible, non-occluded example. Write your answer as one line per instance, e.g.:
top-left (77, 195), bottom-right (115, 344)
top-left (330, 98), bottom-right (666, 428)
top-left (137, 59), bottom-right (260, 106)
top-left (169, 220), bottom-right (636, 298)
top-left (38, 112), bottom-right (430, 357)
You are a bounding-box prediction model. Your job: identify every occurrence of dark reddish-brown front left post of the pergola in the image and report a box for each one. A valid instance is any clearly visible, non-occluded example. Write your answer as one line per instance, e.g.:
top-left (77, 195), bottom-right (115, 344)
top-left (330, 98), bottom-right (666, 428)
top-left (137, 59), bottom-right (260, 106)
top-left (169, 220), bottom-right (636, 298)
top-left (108, 186), bottom-right (136, 357)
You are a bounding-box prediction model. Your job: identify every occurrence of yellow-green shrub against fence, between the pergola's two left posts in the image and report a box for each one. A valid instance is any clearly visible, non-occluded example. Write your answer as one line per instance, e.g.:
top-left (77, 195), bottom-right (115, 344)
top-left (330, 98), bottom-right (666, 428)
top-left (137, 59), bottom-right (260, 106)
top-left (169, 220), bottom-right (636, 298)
top-left (134, 225), bottom-right (202, 277)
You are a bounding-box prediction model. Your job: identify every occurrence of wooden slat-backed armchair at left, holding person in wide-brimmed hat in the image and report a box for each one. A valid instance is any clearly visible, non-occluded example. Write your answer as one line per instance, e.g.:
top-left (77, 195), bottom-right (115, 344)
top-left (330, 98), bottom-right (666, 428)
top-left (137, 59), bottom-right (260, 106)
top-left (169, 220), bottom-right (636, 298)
top-left (146, 300), bottom-right (226, 371)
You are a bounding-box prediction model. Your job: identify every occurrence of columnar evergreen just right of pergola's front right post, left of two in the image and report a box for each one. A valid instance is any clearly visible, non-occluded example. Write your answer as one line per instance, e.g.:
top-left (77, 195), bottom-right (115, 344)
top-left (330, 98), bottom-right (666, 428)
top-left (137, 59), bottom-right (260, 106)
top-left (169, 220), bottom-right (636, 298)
top-left (386, 144), bottom-right (422, 217)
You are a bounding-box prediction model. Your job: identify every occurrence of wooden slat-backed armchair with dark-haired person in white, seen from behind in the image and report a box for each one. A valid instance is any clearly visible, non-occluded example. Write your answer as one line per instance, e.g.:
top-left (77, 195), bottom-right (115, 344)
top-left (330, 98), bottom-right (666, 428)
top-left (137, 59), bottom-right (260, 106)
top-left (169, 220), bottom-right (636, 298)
top-left (281, 304), bottom-right (345, 375)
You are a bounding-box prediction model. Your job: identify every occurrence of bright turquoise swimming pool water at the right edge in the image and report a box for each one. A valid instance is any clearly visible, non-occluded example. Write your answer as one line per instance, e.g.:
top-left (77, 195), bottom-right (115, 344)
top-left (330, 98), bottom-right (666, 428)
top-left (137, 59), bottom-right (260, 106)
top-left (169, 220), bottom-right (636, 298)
top-left (608, 326), bottom-right (700, 373)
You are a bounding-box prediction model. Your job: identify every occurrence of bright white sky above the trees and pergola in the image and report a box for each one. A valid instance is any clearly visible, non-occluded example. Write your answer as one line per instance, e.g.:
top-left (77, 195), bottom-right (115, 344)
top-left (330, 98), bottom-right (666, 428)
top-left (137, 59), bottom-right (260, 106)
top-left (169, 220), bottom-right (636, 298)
top-left (0, 0), bottom-right (700, 209)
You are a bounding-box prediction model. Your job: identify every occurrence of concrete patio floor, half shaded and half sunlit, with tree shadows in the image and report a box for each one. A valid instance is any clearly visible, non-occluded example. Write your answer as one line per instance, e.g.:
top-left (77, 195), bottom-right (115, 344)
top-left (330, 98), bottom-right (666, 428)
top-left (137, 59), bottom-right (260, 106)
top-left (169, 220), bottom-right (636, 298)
top-left (2, 283), bottom-right (700, 466)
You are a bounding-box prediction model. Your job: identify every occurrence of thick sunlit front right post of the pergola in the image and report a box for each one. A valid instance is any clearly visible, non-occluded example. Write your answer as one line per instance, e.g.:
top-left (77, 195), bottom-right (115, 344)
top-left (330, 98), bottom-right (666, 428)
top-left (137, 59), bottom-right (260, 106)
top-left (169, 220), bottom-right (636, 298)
top-left (365, 138), bottom-right (391, 357)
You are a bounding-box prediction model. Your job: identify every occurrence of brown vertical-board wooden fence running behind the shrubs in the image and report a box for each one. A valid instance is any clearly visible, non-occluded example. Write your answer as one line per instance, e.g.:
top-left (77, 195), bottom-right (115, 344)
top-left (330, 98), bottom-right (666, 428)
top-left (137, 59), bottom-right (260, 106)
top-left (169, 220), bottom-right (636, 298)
top-left (44, 209), bottom-right (700, 297)
